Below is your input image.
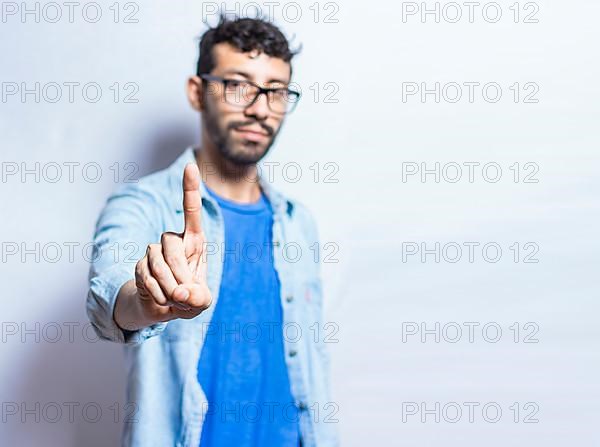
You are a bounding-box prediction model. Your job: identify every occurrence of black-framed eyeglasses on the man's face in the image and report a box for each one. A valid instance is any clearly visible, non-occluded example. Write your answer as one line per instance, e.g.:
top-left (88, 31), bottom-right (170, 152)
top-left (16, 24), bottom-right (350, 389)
top-left (200, 74), bottom-right (300, 115)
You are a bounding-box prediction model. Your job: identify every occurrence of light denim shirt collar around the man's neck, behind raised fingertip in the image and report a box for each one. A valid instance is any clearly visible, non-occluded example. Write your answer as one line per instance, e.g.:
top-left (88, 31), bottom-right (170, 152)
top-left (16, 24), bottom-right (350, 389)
top-left (170, 146), bottom-right (294, 220)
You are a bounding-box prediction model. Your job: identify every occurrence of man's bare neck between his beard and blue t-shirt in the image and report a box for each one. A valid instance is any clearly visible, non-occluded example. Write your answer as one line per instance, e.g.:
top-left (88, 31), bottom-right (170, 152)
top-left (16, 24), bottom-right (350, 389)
top-left (194, 147), bottom-right (260, 203)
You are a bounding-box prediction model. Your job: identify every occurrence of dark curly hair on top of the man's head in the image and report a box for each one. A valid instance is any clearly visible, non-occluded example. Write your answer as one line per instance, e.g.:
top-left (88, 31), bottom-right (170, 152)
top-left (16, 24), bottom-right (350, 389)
top-left (196, 14), bottom-right (300, 76)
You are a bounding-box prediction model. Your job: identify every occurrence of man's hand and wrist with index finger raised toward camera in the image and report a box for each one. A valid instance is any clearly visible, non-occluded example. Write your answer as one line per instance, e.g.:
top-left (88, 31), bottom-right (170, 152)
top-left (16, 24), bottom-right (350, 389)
top-left (114, 163), bottom-right (212, 330)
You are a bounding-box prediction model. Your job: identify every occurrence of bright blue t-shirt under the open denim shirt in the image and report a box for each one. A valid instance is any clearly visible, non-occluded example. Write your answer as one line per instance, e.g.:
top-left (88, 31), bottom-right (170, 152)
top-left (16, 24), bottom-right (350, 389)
top-left (198, 183), bottom-right (299, 447)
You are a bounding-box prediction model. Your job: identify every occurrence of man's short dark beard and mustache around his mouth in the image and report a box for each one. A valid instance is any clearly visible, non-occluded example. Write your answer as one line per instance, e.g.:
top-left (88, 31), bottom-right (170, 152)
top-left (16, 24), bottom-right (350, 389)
top-left (205, 106), bottom-right (279, 167)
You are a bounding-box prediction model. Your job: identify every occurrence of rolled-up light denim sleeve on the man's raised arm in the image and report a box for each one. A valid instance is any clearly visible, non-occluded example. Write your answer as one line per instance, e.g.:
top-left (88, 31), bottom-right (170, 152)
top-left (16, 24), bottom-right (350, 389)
top-left (86, 183), bottom-right (167, 344)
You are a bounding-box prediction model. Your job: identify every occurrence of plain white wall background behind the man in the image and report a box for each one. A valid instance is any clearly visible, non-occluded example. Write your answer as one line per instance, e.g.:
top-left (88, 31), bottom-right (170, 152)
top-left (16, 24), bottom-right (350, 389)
top-left (0, 0), bottom-right (600, 447)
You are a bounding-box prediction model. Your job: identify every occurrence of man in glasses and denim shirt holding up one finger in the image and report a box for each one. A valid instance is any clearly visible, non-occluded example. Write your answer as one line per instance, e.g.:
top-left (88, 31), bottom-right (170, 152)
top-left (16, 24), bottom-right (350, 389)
top-left (87, 14), bottom-right (337, 447)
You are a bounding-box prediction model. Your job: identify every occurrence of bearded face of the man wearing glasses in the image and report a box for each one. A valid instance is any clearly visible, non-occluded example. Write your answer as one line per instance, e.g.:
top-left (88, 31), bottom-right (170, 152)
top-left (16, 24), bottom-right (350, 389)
top-left (188, 43), bottom-right (290, 166)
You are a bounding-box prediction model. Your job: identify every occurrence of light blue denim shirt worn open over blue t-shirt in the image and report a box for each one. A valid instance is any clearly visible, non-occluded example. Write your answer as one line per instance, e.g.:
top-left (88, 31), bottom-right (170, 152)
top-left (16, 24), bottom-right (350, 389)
top-left (87, 147), bottom-right (338, 447)
